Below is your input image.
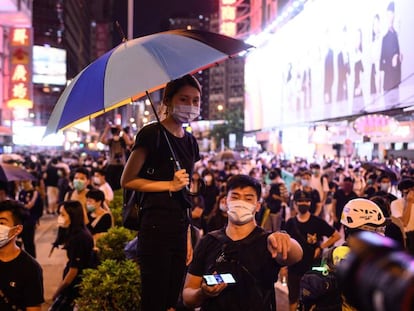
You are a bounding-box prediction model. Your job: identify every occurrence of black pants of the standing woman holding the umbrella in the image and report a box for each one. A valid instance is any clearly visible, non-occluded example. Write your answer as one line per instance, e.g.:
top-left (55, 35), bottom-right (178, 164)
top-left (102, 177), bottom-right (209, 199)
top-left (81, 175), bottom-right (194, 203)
top-left (138, 207), bottom-right (187, 311)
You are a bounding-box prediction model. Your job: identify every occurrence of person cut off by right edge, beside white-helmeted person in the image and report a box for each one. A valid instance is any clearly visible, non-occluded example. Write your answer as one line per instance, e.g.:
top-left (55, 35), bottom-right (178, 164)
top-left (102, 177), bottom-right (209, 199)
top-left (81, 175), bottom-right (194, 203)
top-left (390, 178), bottom-right (414, 255)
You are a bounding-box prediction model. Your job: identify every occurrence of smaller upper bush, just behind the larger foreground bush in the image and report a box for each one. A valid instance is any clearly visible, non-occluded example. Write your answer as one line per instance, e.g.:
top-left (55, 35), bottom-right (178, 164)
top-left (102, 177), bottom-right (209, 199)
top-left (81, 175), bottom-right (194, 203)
top-left (96, 226), bottom-right (137, 261)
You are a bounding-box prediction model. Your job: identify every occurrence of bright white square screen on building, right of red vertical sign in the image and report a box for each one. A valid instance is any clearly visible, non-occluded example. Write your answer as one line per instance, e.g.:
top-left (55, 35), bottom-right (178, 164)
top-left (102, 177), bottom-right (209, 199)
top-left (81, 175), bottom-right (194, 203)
top-left (33, 45), bottom-right (66, 85)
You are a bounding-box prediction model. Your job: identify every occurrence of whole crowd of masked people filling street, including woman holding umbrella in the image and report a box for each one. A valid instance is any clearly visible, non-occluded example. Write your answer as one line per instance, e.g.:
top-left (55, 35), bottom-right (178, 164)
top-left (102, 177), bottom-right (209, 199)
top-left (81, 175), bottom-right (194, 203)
top-left (0, 75), bottom-right (414, 311)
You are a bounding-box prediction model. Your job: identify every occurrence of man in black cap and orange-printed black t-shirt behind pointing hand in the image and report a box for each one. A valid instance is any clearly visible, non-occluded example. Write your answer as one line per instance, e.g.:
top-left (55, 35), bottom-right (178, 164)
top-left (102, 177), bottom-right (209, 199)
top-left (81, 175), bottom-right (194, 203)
top-left (286, 191), bottom-right (341, 311)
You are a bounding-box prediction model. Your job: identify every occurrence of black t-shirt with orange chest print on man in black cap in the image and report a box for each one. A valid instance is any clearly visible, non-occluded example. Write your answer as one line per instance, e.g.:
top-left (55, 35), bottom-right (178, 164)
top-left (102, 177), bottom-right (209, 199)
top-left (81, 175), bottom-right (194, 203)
top-left (286, 215), bottom-right (335, 274)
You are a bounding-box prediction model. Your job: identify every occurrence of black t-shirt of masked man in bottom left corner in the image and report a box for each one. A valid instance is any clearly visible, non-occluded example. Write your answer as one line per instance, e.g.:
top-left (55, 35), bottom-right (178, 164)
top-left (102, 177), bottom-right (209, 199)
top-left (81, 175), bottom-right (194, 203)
top-left (0, 250), bottom-right (44, 311)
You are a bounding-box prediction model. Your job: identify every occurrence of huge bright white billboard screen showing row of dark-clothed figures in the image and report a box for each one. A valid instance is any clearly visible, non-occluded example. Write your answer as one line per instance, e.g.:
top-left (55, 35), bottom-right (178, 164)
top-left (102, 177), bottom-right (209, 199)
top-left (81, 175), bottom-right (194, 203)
top-left (245, 0), bottom-right (414, 131)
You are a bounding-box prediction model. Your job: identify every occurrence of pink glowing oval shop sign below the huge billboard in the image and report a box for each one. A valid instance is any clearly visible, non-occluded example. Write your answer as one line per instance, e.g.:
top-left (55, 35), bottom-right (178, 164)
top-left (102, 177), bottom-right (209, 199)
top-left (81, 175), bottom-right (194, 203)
top-left (354, 114), bottom-right (398, 137)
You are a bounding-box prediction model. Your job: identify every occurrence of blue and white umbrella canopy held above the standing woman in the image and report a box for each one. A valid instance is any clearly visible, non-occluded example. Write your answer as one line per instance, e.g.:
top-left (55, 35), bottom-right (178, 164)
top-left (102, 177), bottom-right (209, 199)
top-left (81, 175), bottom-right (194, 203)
top-left (45, 30), bottom-right (252, 135)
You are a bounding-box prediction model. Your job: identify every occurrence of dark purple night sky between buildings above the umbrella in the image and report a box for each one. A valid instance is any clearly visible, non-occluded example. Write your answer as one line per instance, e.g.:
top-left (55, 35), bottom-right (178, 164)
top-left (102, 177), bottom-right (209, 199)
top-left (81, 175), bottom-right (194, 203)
top-left (114, 0), bottom-right (218, 43)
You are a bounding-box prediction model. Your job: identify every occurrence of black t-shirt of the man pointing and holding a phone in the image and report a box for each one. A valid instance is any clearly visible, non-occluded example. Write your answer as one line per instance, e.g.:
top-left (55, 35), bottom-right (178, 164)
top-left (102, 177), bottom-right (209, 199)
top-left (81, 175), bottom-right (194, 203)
top-left (188, 227), bottom-right (280, 311)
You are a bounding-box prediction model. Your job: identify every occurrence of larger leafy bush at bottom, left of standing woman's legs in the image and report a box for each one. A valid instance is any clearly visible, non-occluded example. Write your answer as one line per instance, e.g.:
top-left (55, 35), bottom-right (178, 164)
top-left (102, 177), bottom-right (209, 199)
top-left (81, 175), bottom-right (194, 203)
top-left (76, 259), bottom-right (141, 311)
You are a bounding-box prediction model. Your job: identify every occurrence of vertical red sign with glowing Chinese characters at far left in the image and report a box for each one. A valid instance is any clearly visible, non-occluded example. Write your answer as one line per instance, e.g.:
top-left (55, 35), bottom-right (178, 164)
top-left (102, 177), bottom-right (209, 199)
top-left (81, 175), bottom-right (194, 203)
top-left (7, 28), bottom-right (33, 109)
